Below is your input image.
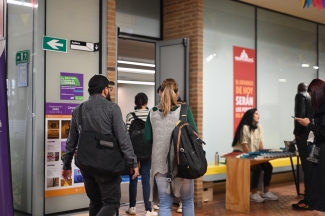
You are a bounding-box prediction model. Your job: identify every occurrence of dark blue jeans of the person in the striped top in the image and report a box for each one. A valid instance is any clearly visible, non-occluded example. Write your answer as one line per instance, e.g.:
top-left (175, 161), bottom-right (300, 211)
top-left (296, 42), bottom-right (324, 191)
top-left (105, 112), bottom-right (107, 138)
top-left (129, 159), bottom-right (151, 211)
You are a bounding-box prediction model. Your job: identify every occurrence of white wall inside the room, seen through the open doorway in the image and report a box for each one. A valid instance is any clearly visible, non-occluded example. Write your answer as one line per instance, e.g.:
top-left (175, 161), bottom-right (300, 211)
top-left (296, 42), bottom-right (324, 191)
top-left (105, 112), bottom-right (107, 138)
top-left (117, 84), bottom-right (155, 121)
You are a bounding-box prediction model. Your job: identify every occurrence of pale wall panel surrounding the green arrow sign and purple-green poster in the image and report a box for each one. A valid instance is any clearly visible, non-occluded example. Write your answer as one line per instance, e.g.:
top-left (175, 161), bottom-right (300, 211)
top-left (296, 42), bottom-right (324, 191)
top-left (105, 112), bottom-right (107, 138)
top-left (46, 0), bottom-right (99, 103)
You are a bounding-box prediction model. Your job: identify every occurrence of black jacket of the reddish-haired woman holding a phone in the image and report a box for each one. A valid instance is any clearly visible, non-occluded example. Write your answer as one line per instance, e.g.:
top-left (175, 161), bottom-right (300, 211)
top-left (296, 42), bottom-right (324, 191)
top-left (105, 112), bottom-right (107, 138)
top-left (307, 103), bottom-right (325, 144)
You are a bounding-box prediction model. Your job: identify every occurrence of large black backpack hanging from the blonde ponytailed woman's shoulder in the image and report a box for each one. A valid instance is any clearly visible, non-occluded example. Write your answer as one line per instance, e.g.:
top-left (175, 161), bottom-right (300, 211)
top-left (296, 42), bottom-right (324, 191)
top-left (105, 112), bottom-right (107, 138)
top-left (167, 104), bottom-right (208, 181)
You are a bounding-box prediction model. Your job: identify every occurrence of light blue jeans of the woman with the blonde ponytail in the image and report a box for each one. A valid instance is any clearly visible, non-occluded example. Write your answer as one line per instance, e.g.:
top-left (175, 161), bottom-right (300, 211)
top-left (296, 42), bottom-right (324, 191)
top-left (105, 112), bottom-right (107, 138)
top-left (155, 173), bottom-right (195, 216)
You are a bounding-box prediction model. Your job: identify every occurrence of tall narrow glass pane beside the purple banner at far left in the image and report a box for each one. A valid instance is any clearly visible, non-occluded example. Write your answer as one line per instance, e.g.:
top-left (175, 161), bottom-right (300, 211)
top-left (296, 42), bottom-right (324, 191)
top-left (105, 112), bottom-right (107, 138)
top-left (7, 0), bottom-right (36, 213)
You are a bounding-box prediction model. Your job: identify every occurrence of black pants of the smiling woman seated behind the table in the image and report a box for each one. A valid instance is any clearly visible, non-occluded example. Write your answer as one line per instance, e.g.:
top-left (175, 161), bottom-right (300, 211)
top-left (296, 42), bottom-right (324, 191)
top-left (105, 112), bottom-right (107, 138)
top-left (251, 162), bottom-right (273, 189)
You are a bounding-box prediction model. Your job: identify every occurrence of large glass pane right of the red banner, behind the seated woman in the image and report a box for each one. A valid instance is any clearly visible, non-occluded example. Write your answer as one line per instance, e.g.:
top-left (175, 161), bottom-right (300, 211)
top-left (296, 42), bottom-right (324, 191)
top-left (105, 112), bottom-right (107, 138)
top-left (257, 9), bottom-right (317, 148)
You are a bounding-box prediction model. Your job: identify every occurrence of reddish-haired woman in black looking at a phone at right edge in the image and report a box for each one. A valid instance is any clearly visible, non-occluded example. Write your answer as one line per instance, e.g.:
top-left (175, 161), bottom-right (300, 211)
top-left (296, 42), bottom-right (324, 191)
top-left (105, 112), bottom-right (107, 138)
top-left (292, 79), bottom-right (325, 212)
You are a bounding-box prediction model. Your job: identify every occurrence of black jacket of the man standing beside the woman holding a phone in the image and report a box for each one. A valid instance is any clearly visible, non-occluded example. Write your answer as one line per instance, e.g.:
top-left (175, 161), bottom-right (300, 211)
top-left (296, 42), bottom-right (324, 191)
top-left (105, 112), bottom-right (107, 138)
top-left (293, 91), bottom-right (314, 136)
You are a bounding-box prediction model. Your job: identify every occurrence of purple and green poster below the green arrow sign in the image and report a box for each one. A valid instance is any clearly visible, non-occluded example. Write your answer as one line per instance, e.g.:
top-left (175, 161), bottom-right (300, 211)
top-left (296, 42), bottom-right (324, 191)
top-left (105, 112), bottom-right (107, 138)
top-left (60, 72), bottom-right (84, 100)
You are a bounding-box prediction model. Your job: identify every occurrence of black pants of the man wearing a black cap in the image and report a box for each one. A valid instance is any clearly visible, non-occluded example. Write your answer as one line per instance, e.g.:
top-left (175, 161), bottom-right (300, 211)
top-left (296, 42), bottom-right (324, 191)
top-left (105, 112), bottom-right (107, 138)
top-left (80, 168), bottom-right (121, 216)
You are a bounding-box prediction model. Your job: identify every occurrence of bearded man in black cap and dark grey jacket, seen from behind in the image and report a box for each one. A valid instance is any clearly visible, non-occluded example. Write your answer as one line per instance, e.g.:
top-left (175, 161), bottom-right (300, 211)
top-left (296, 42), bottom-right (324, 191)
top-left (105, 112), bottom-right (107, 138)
top-left (62, 75), bottom-right (138, 216)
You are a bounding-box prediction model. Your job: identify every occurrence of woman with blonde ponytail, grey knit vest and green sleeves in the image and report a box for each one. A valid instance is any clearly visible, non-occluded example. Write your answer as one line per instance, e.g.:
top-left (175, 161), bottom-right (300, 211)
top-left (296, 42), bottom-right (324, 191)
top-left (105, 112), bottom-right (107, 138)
top-left (144, 79), bottom-right (197, 216)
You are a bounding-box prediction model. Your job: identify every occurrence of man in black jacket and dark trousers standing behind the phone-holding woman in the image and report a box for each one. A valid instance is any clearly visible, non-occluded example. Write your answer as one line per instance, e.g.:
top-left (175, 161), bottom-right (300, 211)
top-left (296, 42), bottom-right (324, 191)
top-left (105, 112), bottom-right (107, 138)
top-left (292, 83), bottom-right (313, 208)
